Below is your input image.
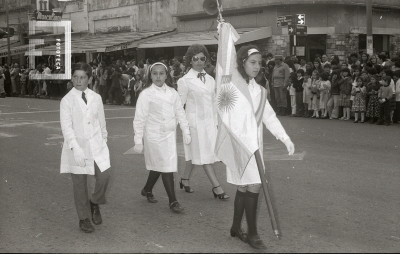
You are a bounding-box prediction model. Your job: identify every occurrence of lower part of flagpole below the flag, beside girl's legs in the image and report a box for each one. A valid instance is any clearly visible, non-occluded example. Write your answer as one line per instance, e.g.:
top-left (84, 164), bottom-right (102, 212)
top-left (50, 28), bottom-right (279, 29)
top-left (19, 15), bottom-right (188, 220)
top-left (254, 149), bottom-right (281, 240)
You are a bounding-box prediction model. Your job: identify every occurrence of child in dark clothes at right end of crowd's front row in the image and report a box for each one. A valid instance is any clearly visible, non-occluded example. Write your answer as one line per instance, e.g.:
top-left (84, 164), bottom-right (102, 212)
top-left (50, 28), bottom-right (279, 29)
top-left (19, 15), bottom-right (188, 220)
top-left (376, 76), bottom-right (393, 126)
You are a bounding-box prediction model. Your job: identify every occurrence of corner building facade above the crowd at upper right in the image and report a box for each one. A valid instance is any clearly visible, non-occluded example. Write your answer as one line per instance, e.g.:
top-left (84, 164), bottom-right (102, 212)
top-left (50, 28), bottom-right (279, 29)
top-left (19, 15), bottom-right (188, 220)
top-left (175, 0), bottom-right (400, 60)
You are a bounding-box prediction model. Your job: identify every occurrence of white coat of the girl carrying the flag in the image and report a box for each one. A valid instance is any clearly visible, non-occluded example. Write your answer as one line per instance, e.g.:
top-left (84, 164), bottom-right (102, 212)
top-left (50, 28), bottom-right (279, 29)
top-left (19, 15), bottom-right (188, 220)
top-left (226, 79), bottom-right (289, 185)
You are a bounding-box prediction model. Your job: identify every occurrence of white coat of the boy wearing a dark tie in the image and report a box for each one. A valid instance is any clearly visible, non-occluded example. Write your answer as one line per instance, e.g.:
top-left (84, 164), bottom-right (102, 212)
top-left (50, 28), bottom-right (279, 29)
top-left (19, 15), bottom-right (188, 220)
top-left (60, 88), bottom-right (110, 175)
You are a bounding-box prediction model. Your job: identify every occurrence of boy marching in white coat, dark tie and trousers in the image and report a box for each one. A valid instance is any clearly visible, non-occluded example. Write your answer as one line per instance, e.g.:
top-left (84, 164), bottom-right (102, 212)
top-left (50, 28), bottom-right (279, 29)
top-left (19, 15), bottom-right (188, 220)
top-left (60, 63), bottom-right (110, 233)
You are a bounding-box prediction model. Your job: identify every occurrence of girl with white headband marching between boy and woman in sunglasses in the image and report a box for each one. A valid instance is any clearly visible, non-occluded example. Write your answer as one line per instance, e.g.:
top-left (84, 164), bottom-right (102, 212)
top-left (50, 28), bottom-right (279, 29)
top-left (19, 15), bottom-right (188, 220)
top-left (133, 62), bottom-right (191, 213)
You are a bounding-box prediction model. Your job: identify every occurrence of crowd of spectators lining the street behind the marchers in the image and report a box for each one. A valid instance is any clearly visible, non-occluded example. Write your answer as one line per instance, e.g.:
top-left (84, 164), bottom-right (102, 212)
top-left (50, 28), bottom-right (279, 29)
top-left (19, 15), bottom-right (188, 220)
top-left (0, 49), bottom-right (400, 125)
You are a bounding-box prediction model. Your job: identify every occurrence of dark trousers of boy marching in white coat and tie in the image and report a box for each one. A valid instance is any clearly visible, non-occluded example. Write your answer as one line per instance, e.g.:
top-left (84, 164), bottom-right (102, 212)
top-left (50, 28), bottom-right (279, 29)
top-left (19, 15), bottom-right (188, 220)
top-left (71, 163), bottom-right (110, 220)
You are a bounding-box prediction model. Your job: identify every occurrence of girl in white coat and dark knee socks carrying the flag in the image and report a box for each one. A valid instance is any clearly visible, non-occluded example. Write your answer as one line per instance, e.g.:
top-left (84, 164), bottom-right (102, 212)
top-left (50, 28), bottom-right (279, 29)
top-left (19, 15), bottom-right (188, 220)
top-left (226, 45), bottom-right (294, 249)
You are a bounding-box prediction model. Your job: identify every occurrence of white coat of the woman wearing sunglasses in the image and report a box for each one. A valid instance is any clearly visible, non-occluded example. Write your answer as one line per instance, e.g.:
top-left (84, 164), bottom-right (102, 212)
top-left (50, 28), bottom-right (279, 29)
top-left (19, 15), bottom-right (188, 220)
top-left (178, 69), bottom-right (218, 165)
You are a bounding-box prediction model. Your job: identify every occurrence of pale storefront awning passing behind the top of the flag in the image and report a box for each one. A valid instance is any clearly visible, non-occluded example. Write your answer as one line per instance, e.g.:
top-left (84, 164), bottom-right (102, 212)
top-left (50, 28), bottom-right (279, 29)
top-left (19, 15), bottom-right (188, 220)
top-left (138, 27), bottom-right (271, 48)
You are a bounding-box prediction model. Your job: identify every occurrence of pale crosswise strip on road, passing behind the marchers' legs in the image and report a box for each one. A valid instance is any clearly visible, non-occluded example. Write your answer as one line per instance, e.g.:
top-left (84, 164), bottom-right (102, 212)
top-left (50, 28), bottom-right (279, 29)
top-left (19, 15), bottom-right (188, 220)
top-left (123, 143), bottom-right (306, 161)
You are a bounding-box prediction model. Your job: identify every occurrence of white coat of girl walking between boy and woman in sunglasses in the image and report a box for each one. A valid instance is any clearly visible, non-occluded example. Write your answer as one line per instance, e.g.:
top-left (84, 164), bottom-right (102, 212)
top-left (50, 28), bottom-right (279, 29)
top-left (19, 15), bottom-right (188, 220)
top-left (133, 84), bottom-right (190, 173)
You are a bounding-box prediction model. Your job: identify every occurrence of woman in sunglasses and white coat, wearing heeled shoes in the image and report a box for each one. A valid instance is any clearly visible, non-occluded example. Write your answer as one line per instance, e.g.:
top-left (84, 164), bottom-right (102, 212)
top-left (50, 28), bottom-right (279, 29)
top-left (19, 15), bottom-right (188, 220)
top-left (178, 44), bottom-right (229, 200)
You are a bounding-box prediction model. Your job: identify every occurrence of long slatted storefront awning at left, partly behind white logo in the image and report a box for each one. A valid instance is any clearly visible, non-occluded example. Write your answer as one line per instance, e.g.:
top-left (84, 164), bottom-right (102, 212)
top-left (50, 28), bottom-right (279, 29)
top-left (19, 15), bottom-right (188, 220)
top-left (25, 29), bottom-right (176, 55)
